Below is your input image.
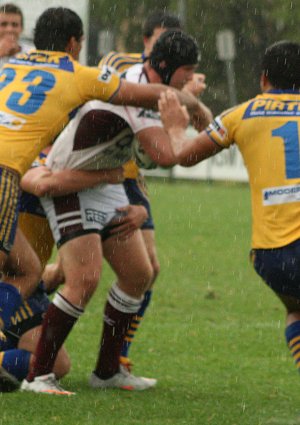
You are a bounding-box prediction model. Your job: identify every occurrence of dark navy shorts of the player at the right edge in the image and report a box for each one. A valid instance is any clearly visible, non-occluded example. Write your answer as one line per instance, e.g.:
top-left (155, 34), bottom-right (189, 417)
top-left (251, 239), bottom-right (300, 299)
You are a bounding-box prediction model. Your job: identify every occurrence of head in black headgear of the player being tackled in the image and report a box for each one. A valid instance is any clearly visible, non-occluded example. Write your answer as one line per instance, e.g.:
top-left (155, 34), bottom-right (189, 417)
top-left (149, 30), bottom-right (199, 89)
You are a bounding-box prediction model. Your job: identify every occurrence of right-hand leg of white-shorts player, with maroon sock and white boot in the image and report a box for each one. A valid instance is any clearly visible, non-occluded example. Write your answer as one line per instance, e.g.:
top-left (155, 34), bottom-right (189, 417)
top-left (90, 231), bottom-right (156, 390)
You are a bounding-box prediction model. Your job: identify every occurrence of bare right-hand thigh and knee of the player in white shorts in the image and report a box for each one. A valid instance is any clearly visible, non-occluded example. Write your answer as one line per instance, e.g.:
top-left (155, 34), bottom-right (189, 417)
top-left (103, 230), bottom-right (153, 296)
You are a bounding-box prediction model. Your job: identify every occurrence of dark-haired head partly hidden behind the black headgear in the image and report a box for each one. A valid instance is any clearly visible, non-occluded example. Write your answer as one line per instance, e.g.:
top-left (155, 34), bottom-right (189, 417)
top-left (143, 10), bottom-right (181, 56)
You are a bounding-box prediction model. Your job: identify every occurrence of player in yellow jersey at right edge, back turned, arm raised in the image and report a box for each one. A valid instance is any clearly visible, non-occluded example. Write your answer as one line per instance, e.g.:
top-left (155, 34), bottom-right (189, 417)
top-left (160, 41), bottom-right (300, 376)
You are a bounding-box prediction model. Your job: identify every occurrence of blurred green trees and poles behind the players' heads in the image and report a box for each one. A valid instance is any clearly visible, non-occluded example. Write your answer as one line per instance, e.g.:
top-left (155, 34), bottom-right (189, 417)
top-left (88, 0), bottom-right (300, 114)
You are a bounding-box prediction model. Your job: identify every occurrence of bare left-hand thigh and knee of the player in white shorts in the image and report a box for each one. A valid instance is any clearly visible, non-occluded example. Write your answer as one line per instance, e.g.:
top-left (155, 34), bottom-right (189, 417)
top-left (59, 233), bottom-right (102, 307)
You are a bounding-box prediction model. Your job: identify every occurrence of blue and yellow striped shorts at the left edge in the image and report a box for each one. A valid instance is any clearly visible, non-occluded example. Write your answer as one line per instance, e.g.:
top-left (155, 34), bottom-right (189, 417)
top-left (0, 168), bottom-right (20, 254)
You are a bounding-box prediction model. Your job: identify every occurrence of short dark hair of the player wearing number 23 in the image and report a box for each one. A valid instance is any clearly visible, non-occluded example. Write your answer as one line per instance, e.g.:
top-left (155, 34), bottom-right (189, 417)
top-left (33, 7), bottom-right (83, 52)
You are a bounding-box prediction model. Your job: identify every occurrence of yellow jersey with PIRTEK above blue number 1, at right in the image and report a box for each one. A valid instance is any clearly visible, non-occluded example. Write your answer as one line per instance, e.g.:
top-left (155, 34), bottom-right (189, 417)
top-left (207, 90), bottom-right (300, 249)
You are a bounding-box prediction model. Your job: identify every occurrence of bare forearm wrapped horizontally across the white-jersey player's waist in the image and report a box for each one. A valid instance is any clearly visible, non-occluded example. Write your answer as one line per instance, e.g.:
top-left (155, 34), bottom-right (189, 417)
top-left (21, 166), bottom-right (124, 196)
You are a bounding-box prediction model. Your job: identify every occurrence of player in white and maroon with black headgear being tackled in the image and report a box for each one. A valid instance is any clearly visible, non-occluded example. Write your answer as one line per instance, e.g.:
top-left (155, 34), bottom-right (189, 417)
top-left (22, 31), bottom-right (211, 392)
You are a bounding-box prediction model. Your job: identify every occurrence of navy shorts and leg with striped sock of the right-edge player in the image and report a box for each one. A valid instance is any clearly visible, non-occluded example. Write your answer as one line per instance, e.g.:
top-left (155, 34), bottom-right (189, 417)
top-left (253, 240), bottom-right (300, 371)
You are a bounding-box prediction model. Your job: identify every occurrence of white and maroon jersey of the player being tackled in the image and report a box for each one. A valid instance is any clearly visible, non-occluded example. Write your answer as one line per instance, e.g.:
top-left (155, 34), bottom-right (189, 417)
top-left (46, 64), bottom-right (162, 170)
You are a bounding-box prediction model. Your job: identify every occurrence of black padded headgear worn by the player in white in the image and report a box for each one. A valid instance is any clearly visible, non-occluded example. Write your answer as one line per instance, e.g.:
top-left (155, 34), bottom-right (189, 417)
top-left (149, 30), bottom-right (199, 85)
